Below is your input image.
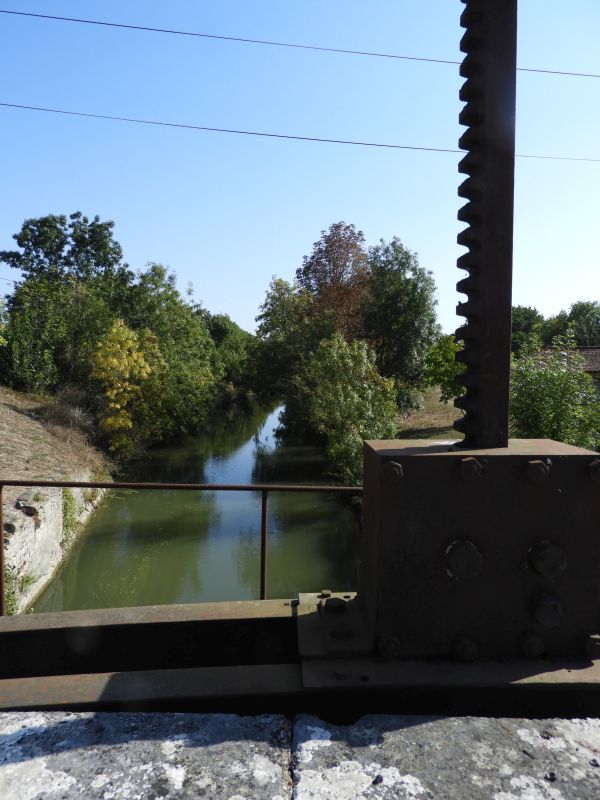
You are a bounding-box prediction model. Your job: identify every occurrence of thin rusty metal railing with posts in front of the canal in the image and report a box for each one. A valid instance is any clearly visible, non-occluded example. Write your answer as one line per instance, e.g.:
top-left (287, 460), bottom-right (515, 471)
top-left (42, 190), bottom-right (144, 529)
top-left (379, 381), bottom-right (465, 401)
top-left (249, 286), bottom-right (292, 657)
top-left (0, 480), bottom-right (363, 616)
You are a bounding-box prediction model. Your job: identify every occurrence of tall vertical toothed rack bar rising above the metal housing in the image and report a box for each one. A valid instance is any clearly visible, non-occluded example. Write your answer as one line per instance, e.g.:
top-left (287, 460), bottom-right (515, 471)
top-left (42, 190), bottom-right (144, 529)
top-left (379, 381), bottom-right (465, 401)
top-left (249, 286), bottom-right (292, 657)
top-left (454, 0), bottom-right (517, 448)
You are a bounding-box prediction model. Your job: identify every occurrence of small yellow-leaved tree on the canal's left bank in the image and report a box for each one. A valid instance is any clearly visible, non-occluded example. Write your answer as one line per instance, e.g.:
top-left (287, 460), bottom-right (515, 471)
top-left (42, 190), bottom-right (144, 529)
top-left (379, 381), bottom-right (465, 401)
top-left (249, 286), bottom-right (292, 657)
top-left (92, 319), bottom-right (152, 454)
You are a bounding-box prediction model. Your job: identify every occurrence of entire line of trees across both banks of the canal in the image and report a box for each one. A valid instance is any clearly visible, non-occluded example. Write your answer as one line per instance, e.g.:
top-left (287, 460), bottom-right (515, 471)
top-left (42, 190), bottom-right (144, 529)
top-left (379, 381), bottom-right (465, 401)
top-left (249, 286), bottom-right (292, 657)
top-left (0, 212), bottom-right (600, 476)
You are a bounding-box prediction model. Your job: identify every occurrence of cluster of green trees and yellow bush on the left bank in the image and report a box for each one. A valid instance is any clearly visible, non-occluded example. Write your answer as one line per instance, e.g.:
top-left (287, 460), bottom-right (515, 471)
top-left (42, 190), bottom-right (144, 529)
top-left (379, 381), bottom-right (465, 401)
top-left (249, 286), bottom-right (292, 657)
top-left (0, 212), bottom-right (254, 455)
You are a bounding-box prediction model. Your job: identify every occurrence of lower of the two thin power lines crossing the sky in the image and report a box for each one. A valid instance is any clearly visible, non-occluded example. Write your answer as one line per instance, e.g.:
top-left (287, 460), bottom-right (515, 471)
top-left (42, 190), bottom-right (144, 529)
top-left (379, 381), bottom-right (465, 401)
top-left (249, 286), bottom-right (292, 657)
top-left (0, 102), bottom-right (600, 162)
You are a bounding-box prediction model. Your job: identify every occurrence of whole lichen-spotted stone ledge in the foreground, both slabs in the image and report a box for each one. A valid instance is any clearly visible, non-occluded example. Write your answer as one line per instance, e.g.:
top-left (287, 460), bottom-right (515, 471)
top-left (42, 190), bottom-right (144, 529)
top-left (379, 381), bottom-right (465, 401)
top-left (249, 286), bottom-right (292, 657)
top-left (0, 712), bottom-right (600, 800)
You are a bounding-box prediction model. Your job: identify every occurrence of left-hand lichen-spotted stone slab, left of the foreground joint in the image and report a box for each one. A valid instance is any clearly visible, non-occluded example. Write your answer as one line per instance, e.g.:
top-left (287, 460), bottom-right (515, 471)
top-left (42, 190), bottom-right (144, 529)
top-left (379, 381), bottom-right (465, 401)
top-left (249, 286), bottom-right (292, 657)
top-left (0, 712), bottom-right (291, 800)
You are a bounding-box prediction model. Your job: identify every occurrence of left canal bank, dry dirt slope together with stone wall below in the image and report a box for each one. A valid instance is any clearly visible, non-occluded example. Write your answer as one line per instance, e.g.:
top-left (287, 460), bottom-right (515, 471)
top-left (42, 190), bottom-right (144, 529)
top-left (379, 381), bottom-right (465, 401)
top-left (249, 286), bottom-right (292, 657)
top-left (0, 386), bottom-right (109, 613)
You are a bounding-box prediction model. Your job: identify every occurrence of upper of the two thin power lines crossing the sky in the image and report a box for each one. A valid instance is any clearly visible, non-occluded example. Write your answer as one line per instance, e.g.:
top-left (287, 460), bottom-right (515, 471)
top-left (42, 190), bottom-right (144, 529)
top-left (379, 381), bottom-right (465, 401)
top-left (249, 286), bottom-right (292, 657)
top-left (0, 8), bottom-right (600, 78)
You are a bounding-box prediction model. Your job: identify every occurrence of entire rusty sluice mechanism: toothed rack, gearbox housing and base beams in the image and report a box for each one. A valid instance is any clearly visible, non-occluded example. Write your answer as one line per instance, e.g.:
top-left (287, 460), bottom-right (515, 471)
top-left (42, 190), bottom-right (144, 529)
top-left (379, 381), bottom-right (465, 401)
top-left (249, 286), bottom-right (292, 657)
top-left (0, 0), bottom-right (600, 716)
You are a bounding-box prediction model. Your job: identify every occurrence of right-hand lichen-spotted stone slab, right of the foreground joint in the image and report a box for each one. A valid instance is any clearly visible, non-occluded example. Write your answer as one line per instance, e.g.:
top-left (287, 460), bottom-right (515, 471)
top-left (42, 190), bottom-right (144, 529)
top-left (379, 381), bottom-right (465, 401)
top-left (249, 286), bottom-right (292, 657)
top-left (293, 716), bottom-right (600, 800)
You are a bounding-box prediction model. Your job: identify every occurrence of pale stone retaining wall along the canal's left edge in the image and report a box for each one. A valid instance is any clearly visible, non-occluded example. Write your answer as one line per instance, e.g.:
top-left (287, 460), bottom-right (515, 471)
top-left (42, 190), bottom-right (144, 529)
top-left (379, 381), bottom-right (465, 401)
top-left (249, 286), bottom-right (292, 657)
top-left (4, 475), bottom-right (102, 613)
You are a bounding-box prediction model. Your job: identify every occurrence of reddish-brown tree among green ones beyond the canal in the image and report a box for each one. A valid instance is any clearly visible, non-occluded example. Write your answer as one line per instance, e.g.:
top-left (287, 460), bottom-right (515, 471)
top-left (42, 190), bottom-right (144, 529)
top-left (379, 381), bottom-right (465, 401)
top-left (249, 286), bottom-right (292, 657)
top-left (296, 222), bottom-right (369, 339)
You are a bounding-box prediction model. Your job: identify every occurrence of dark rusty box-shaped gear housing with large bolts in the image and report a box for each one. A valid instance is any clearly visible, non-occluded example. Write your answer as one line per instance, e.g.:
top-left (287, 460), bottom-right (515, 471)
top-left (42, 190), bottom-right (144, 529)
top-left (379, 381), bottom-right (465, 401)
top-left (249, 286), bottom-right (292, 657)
top-left (359, 440), bottom-right (600, 661)
